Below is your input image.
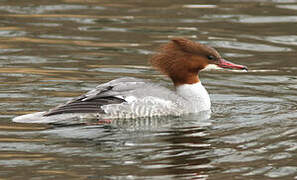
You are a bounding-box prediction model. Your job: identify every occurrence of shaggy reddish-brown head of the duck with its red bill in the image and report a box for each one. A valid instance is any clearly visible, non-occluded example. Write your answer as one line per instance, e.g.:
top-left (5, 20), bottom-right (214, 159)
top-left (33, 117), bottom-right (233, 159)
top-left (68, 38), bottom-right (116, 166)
top-left (150, 38), bottom-right (247, 86)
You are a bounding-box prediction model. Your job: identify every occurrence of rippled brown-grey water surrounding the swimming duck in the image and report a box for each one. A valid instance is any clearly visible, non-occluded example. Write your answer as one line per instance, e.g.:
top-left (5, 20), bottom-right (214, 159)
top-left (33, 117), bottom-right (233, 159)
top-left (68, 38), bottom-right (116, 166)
top-left (0, 0), bottom-right (297, 180)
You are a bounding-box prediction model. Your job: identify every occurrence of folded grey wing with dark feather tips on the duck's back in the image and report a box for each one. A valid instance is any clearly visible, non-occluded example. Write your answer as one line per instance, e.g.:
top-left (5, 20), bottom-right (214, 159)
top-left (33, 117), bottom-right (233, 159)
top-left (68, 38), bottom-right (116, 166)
top-left (43, 77), bottom-right (146, 116)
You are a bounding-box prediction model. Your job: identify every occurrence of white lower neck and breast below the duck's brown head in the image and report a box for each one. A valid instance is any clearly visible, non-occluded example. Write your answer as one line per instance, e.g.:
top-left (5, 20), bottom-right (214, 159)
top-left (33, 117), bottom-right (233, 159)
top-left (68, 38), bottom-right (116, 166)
top-left (176, 82), bottom-right (211, 112)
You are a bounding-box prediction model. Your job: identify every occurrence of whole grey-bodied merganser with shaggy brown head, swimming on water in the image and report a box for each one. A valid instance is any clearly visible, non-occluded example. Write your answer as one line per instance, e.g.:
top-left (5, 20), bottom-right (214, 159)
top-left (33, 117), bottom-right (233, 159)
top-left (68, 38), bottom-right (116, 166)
top-left (13, 38), bottom-right (247, 123)
